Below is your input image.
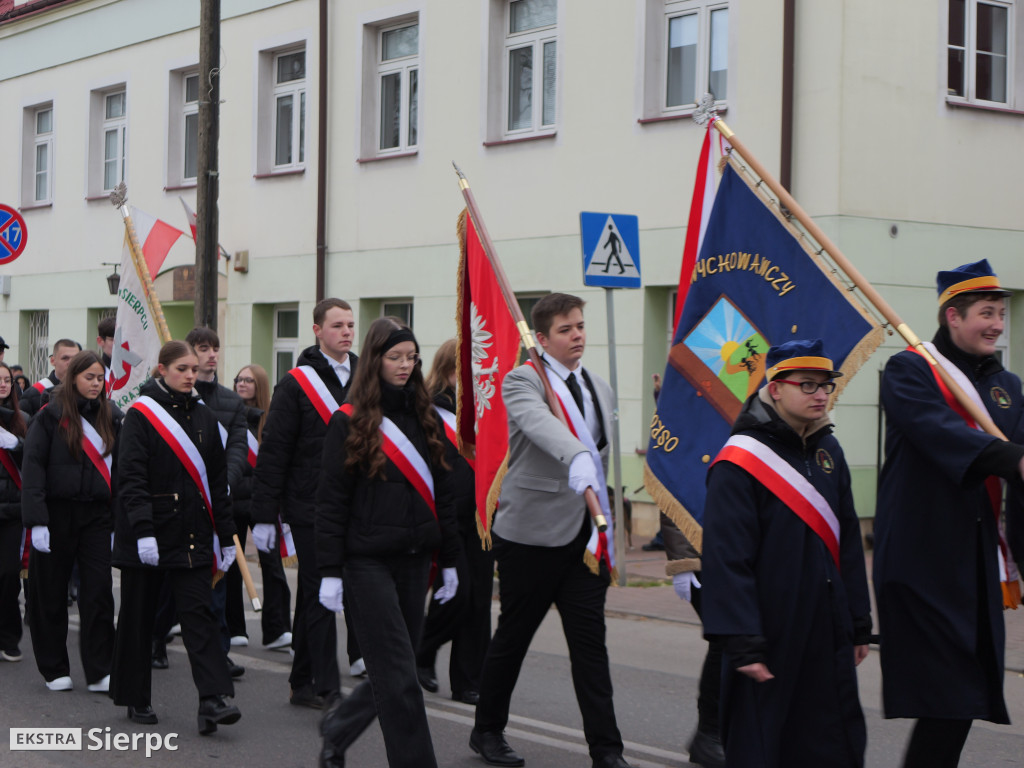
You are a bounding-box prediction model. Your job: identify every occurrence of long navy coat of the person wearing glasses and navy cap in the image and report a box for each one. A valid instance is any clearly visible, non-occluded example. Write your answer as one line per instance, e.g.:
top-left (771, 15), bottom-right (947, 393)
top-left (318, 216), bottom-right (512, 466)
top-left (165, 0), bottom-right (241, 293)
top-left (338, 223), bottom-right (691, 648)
top-left (701, 394), bottom-right (871, 768)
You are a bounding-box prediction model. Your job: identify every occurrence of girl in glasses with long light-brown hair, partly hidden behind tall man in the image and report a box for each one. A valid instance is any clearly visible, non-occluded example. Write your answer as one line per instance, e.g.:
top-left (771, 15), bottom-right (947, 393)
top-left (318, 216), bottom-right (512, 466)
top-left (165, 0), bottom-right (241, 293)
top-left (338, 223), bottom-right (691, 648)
top-left (232, 362), bottom-right (292, 650)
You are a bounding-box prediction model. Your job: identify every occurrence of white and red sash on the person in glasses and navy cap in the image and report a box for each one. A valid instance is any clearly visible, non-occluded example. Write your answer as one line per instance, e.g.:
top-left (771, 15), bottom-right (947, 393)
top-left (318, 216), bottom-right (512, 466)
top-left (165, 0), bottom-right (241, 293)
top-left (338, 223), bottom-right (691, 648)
top-left (712, 435), bottom-right (840, 570)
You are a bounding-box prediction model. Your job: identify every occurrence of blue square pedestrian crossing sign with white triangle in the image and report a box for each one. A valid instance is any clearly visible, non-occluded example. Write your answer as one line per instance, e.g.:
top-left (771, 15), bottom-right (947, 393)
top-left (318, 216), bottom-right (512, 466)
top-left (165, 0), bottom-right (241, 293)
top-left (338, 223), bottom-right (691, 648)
top-left (580, 211), bottom-right (640, 288)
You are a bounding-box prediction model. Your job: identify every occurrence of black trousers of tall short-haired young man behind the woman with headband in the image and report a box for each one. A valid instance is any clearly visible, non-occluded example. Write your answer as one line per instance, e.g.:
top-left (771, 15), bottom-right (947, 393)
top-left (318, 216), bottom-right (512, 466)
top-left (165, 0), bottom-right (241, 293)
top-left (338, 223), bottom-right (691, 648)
top-left (288, 525), bottom-right (339, 697)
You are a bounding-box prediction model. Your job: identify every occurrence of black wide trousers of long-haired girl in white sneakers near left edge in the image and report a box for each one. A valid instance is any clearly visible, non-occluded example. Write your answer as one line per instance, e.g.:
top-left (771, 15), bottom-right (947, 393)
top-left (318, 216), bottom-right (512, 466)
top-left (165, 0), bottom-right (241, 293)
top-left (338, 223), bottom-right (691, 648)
top-left (29, 512), bottom-right (114, 684)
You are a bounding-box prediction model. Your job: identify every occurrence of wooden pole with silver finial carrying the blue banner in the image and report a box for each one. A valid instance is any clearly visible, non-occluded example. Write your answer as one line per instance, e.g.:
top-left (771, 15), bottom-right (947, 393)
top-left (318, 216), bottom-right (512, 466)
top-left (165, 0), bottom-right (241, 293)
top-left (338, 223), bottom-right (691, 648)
top-left (693, 94), bottom-right (1007, 440)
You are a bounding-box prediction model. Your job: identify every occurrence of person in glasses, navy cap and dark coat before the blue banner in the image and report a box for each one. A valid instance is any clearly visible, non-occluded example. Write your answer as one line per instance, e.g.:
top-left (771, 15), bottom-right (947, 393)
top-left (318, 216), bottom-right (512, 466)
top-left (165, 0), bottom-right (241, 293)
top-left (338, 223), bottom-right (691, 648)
top-left (701, 339), bottom-right (871, 768)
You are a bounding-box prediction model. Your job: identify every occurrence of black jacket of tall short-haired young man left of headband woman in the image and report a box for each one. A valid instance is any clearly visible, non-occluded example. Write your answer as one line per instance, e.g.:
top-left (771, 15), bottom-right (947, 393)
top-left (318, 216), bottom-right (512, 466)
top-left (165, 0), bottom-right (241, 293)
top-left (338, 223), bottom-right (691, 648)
top-left (252, 346), bottom-right (358, 526)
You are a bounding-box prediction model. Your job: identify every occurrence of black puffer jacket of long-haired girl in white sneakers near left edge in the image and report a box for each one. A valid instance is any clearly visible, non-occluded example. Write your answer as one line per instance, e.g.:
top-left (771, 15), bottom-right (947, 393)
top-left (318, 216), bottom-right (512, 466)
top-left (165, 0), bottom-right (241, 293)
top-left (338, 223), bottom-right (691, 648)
top-left (22, 397), bottom-right (122, 528)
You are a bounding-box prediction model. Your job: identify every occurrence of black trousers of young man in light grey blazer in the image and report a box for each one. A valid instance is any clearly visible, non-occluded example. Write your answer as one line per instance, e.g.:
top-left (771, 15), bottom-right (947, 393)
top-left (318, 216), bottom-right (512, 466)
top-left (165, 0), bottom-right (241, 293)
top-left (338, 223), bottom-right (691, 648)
top-left (476, 519), bottom-right (623, 761)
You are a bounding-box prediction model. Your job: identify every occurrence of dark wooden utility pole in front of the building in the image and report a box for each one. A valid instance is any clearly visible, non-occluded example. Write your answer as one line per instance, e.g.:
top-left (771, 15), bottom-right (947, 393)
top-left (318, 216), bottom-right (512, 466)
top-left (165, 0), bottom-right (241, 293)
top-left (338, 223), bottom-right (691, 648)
top-left (195, 0), bottom-right (220, 331)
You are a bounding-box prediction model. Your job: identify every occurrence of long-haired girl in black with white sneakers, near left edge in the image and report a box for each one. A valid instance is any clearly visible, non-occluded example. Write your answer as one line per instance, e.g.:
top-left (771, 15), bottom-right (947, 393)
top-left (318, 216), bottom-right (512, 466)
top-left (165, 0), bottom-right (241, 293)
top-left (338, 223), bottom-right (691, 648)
top-left (22, 347), bottom-right (121, 691)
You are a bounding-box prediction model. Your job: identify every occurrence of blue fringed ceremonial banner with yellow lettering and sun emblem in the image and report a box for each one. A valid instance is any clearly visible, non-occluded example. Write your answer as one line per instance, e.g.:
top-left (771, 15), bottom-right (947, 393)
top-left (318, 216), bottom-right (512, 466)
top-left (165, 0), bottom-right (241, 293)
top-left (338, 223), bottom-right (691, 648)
top-left (644, 163), bottom-right (882, 551)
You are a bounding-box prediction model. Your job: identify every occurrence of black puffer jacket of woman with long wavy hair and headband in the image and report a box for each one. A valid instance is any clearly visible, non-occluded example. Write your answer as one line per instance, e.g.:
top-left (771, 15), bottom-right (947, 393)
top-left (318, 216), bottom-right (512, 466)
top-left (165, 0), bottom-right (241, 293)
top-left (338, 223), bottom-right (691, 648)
top-left (316, 384), bottom-right (459, 577)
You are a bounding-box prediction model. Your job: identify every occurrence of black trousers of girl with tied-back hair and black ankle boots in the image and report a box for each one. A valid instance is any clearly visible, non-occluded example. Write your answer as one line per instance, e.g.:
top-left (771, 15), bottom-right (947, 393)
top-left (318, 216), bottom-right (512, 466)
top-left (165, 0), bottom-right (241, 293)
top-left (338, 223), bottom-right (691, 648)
top-left (111, 565), bottom-right (234, 707)
